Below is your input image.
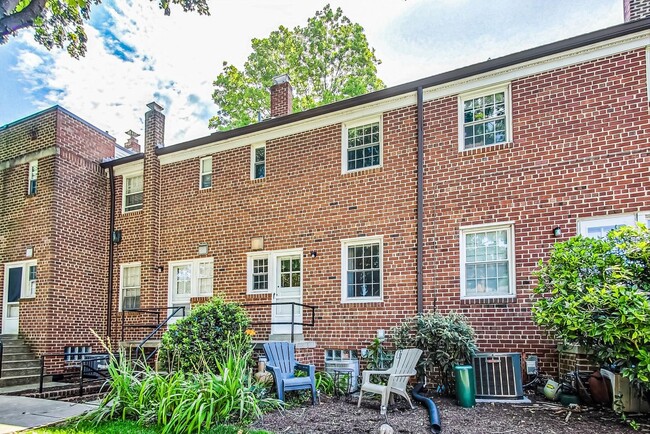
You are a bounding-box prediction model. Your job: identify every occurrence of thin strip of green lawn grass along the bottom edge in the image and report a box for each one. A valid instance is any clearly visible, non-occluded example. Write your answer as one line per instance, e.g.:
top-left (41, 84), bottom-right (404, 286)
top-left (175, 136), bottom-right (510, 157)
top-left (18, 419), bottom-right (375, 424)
top-left (27, 420), bottom-right (269, 434)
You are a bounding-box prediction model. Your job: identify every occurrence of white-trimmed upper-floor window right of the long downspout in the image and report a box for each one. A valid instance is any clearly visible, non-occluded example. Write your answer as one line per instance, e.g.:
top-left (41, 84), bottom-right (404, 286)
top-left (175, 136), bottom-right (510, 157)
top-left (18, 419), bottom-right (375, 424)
top-left (458, 86), bottom-right (512, 151)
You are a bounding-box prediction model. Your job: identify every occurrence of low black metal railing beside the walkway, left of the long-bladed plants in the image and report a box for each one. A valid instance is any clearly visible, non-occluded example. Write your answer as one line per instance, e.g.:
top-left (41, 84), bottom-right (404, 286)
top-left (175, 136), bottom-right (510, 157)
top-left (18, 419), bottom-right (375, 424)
top-left (38, 352), bottom-right (111, 396)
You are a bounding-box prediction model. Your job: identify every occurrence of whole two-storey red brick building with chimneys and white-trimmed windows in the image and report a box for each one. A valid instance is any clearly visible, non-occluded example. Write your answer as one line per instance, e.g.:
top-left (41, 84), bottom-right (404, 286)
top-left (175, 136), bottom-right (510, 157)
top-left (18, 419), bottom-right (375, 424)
top-left (0, 1), bottom-right (650, 369)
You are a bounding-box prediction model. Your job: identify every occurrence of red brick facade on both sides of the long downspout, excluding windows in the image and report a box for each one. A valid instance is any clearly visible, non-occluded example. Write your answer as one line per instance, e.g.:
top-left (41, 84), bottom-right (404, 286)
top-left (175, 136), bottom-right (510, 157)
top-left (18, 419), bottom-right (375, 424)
top-left (104, 50), bottom-right (650, 372)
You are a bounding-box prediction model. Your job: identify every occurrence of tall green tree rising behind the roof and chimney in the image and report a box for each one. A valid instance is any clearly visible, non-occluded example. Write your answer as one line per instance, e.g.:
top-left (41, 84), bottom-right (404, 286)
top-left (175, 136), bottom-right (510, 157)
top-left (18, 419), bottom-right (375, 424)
top-left (210, 5), bottom-right (385, 130)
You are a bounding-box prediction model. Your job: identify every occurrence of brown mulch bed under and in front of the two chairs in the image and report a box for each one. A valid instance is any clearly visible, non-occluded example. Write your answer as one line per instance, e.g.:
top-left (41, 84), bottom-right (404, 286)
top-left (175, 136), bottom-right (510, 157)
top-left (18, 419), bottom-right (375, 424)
top-left (253, 396), bottom-right (650, 434)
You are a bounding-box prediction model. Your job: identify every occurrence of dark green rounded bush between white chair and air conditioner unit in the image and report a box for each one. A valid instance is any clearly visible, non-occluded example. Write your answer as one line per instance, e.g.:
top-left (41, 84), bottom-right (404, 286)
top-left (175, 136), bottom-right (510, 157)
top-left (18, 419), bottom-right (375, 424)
top-left (392, 312), bottom-right (477, 389)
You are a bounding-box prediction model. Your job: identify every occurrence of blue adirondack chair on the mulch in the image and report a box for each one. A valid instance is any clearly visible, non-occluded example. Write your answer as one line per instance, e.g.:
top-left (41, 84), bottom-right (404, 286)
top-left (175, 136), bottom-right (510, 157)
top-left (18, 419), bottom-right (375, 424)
top-left (264, 342), bottom-right (316, 405)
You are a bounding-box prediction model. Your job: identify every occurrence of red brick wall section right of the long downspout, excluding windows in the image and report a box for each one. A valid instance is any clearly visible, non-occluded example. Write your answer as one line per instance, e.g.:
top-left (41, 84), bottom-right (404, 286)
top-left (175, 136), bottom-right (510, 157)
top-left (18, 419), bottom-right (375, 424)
top-left (424, 50), bottom-right (650, 372)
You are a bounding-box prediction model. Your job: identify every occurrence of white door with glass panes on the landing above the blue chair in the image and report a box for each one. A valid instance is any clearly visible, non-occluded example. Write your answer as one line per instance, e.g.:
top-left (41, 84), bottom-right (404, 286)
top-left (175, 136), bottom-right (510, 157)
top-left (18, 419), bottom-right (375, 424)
top-left (271, 255), bottom-right (302, 335)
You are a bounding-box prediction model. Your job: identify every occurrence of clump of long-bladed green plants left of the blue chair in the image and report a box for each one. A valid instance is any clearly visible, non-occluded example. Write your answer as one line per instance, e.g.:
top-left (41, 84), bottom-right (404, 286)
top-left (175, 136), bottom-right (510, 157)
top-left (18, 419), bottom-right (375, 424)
top-left (86, 340), bottom-right (280, 434)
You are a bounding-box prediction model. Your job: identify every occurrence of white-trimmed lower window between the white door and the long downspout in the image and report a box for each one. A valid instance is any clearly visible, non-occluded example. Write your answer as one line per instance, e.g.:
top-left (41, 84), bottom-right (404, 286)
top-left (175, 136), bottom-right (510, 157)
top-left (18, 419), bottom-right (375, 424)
top-left (341, 236), bottom-right (383, 303)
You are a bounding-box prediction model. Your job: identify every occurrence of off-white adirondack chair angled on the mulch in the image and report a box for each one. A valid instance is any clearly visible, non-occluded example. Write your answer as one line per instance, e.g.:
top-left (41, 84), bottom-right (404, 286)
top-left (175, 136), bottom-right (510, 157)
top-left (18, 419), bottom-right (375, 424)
top-left (357, 348), bottom-right (422, 415)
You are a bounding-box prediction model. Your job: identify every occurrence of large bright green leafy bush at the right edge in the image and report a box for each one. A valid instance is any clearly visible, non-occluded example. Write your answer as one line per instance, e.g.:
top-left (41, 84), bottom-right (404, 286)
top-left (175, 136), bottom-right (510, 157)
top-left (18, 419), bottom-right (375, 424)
top-left (533, 225), bottom-right (650, 393)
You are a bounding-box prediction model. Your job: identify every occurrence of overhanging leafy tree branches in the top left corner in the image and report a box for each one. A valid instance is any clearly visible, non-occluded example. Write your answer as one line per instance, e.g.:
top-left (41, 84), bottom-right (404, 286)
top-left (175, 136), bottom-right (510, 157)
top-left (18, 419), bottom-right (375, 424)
top-left (0, 0), bottom-right (210, 58)
